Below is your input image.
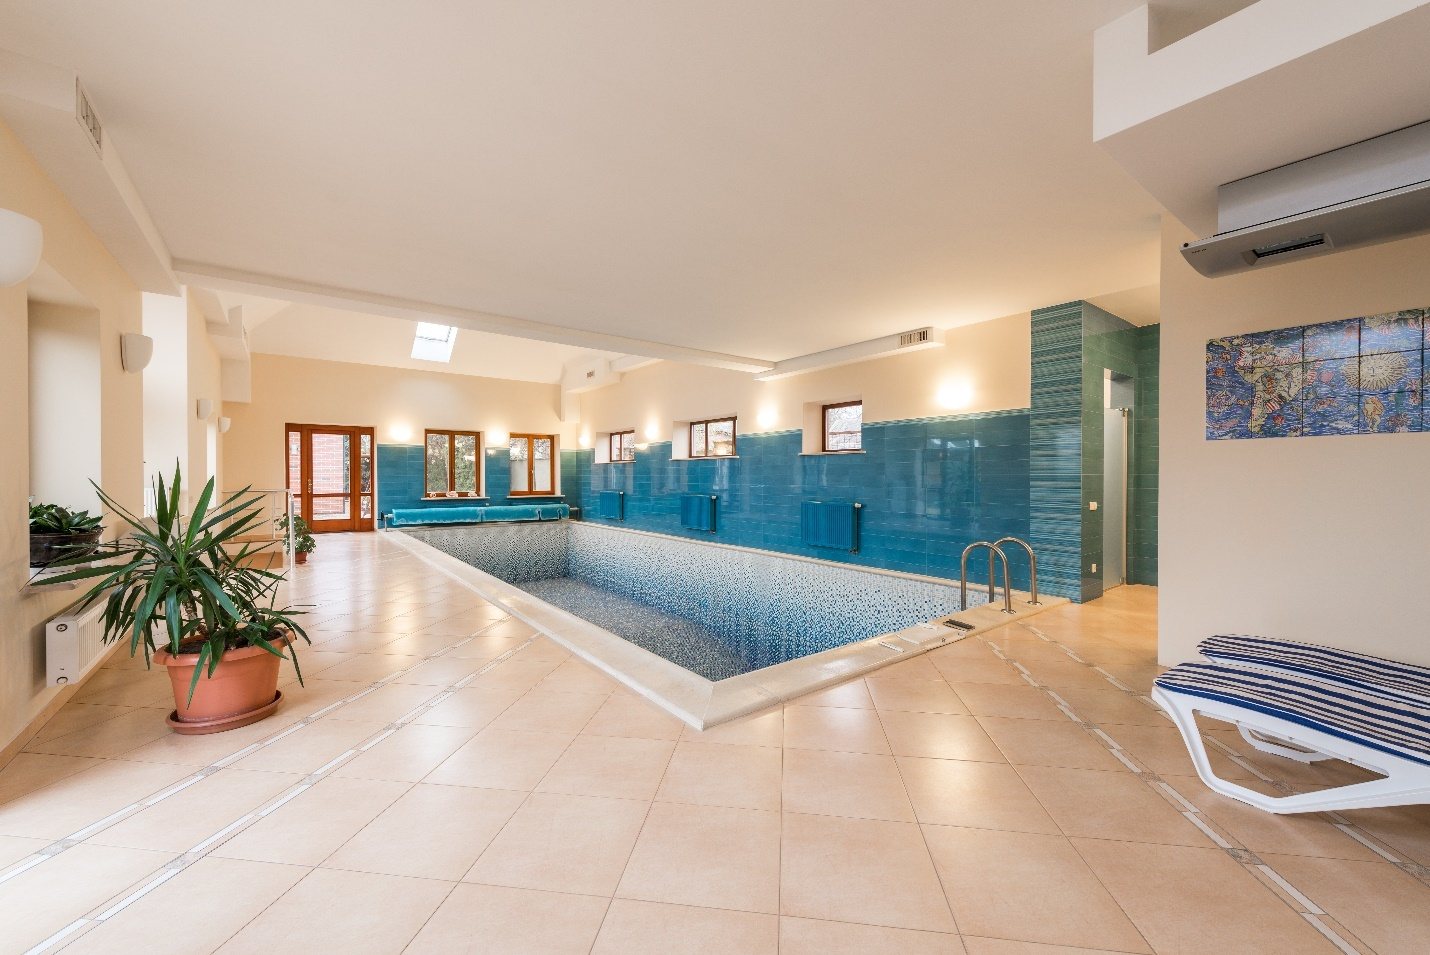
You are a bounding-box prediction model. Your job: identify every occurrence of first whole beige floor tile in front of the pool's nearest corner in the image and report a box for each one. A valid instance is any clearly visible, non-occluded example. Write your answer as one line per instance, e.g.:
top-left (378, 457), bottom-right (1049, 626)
top-left (655, 742), bottom-right (782, 809)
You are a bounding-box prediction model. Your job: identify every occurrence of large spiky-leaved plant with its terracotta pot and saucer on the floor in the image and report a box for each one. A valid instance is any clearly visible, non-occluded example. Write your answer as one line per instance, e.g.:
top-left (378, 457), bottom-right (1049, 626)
top-left (44, 467), bottom-right (307, 733)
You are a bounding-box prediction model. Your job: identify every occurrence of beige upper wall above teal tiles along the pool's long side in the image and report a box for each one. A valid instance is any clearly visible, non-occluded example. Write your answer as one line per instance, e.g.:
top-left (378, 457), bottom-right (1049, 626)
top-left (581, 313), bottom-right (1031, 440)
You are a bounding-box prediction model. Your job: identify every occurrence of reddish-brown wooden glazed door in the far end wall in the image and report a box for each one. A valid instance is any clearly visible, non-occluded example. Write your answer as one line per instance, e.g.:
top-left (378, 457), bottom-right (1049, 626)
top-left (285, 425), bottom-right (378, 533)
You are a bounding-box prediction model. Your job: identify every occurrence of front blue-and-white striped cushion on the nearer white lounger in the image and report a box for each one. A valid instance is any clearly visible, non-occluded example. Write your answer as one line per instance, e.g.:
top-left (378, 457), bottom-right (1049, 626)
top-left (1157, 663), bottom-right (1430, 766)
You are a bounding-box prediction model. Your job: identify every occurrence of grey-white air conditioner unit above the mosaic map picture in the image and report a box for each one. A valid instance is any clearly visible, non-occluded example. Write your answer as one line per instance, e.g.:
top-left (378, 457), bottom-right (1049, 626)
top-left (1181, 123), bottom-right (1430, 277)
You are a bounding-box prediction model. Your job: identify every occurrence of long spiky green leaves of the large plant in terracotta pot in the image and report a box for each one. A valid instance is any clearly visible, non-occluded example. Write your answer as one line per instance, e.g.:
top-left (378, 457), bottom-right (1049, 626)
top-left (44, 466), bottom-right (312, 702)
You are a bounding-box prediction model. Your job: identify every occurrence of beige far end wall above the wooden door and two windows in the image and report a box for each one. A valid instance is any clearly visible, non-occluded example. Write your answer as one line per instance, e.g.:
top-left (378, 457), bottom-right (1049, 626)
top-left (222, 355), bottom-right (575, 490)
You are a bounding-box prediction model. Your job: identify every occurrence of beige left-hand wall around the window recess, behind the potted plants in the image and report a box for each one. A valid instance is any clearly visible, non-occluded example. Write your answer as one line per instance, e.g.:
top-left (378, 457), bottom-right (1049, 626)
top-left (0, 123), bottom-right (143, 751)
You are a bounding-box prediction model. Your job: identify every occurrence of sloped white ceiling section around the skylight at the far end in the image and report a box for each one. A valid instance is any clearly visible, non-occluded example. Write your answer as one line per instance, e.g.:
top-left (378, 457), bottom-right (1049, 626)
top-left (245, 305), bottom-right (615, 383)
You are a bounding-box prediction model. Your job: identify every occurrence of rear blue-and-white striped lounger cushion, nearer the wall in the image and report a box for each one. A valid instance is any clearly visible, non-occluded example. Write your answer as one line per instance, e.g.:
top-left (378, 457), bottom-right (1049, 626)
top-left (1197, 636), bottom-right (1430, 702)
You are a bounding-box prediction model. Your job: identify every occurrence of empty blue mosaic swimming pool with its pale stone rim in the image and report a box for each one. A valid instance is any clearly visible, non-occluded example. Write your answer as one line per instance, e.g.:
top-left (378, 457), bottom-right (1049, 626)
top-left (393, 522), bottom-right (1065, 728)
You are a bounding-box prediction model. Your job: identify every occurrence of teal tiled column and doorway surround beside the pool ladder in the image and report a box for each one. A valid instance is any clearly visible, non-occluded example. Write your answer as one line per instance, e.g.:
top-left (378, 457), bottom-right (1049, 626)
top-left (1030, 302), bottom-right (1160, 602)
